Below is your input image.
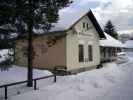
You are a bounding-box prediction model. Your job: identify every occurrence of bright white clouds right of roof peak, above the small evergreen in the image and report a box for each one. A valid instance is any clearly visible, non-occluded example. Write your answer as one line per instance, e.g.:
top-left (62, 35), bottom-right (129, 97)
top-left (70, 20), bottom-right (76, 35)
top-left (93, 0), bottom-right (133, 30)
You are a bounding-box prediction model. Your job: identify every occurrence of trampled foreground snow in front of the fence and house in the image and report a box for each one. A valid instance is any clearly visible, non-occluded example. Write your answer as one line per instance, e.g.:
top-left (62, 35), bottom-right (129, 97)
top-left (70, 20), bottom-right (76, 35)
top-left (0, 52), bottom-right (133, 100)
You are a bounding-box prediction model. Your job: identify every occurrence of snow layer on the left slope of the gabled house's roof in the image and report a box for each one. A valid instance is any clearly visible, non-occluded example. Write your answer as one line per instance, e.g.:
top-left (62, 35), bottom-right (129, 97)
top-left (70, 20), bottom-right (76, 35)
top-left (34, 7), bottom-right (89, 34)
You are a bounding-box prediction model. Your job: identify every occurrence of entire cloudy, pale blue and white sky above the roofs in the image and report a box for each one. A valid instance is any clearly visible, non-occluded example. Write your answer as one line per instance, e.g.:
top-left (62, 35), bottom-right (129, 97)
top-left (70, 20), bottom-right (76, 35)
top-left (65, 0), bottom-right (133, 31)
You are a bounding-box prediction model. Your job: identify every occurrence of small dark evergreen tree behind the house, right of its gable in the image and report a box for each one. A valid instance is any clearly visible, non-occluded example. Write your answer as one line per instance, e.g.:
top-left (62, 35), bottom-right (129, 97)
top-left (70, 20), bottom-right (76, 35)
top-left (104, 20), bottom-right (118, 39)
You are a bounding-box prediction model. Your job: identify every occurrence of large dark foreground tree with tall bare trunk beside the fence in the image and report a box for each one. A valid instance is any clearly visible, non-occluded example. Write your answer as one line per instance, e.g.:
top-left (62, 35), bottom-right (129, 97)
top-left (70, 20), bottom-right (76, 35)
top-left (0, 0), bottom-right (70, 86)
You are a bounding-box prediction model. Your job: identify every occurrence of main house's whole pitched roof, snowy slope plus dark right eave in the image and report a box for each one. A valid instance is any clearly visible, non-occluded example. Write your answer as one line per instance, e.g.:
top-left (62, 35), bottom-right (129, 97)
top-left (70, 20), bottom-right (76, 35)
top-left (34, 8), bottom-right (105, 38)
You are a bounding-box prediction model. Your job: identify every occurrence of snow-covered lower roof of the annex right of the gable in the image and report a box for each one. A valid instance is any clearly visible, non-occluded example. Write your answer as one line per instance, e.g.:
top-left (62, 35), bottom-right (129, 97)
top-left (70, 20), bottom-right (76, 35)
top-left (100, 32), bottom-right (123, 47)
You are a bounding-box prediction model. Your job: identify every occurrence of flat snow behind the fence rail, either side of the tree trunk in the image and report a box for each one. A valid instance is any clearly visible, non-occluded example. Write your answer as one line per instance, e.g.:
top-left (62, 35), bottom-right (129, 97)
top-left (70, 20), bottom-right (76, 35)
top-left (0, 65), bottom-right (52, 85)
